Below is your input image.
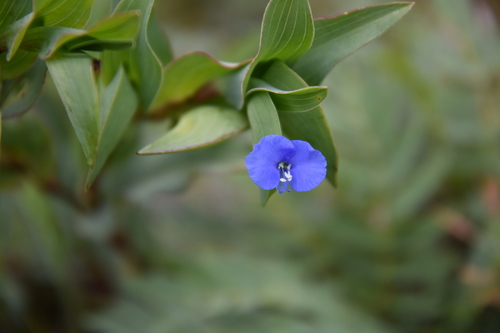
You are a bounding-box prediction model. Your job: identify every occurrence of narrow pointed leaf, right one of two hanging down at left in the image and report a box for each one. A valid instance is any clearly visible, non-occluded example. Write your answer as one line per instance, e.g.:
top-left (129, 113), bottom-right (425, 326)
top-left (86, 69), bottom-right (137, 189)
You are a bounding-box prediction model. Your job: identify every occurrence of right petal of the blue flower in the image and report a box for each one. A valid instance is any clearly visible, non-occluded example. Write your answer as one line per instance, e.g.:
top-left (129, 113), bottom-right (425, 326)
top-left (288, 140), bottom-right (326, 192)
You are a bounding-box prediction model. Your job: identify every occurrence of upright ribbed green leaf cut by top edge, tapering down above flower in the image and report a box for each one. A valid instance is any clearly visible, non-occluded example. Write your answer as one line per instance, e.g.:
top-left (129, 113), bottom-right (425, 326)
top-left (232, 0), bottom-right (314, 108)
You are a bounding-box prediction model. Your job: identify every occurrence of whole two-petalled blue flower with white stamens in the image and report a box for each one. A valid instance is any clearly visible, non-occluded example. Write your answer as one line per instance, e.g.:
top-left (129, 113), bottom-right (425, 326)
top-left (245, 135), bottom-right (326, 193)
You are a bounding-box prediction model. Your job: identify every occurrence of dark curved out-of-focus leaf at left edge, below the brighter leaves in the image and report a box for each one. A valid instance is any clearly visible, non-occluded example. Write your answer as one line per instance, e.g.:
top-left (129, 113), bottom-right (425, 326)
top-left (0, 60), bottom-right (46, 118)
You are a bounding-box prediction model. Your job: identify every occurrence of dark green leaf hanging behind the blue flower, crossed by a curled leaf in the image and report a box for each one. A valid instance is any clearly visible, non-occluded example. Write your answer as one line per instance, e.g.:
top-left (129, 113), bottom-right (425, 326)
top-left (262, 61), bottom-right (338, 186)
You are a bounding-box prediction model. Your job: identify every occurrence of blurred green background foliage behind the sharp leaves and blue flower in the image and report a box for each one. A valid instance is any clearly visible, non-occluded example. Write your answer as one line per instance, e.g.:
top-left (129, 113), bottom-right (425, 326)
top-left (0, 0), bottom-right (500, 333)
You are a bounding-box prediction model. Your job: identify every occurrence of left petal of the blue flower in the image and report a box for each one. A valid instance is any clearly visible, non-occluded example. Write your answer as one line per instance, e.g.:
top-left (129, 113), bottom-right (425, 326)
top-left (245, 135), bottom-right (295, 190)
